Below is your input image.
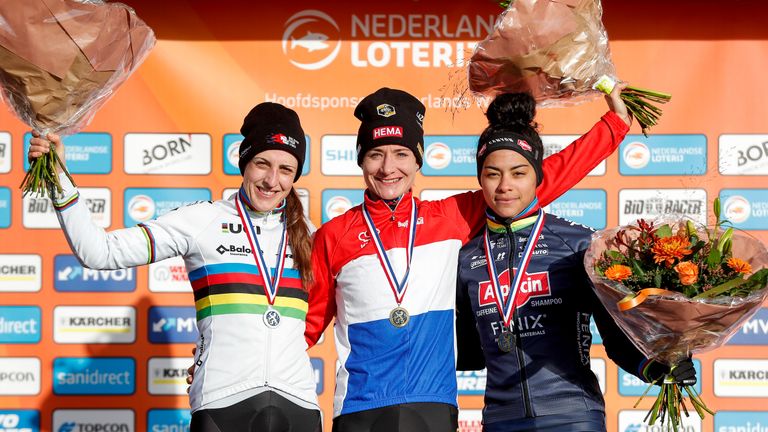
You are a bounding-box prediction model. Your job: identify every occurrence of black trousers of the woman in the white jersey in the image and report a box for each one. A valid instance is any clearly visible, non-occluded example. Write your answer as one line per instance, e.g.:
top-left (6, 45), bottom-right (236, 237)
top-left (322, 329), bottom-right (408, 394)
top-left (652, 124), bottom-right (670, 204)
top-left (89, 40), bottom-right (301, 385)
top-left (189, 391), bottom-right (322, 432)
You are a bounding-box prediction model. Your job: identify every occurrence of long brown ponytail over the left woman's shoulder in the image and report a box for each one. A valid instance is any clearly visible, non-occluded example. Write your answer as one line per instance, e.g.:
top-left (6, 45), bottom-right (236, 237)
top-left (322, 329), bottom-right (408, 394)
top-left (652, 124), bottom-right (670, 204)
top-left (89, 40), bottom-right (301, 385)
top-left (285, 188), bottom-right (313, 291)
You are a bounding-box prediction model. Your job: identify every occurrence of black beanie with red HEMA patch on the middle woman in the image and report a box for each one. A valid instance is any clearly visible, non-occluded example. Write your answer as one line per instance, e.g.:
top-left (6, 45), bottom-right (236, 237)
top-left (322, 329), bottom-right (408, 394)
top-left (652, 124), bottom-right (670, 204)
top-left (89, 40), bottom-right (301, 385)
top-left (355, 87), bottom-right (426, 167)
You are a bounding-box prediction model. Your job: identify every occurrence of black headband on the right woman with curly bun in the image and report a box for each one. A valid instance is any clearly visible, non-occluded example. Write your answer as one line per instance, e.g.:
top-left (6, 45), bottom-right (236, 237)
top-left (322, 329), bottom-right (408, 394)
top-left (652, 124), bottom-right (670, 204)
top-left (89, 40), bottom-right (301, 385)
top-left (475, 131), bottom-right (544, 186)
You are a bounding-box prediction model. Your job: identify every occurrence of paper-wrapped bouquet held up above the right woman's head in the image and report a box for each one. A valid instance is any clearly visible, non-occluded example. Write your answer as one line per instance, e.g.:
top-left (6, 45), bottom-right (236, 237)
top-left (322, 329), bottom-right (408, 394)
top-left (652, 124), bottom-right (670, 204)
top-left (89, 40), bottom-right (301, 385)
top-left (468, 0), bottom-right (671, 133)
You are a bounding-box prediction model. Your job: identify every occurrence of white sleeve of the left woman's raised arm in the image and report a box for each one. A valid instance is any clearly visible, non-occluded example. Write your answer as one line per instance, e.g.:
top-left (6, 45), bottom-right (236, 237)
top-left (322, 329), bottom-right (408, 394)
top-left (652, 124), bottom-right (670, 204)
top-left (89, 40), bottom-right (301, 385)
top-left (52, 174), bottom-right (201, 270)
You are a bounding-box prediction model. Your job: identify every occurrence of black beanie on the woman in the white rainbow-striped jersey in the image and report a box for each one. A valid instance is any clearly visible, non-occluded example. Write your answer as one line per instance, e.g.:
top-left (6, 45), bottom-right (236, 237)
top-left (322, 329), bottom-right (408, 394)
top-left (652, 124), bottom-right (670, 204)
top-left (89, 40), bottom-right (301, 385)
top-left (238, 102), bottom-right (307, 181)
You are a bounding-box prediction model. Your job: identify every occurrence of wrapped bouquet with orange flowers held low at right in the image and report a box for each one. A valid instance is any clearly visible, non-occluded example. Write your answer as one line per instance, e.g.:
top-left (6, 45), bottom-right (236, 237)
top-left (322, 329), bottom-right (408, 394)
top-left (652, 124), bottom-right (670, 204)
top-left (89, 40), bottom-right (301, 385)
top-left (584, 199), bottom-right (768, 430)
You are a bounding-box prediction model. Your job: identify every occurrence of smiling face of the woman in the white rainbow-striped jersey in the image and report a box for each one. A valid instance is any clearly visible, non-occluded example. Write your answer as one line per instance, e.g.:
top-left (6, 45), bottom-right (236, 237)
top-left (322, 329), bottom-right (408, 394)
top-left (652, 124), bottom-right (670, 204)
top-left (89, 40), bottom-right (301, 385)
top-left (243, 150), bottom-right (299, 212)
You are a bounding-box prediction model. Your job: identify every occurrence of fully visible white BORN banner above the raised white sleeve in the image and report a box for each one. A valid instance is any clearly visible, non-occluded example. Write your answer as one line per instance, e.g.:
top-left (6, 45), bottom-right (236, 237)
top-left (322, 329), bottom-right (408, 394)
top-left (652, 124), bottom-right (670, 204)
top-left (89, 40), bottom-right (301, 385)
top-left (125, 133), bottom-right (211, 174)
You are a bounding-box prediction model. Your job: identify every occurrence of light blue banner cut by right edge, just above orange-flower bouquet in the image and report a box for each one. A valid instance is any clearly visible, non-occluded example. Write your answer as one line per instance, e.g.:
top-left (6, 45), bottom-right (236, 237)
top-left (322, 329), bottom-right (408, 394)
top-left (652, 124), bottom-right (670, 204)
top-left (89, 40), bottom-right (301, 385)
top-left (720, 189), bottom-right (768, 230)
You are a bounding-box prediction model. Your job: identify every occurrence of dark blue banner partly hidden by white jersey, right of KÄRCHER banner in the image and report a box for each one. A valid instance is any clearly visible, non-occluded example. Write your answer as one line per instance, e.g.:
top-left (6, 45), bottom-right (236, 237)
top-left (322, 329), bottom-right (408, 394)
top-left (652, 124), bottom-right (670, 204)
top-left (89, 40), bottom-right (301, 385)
top-left (147, 306), bottom-right (198, 343)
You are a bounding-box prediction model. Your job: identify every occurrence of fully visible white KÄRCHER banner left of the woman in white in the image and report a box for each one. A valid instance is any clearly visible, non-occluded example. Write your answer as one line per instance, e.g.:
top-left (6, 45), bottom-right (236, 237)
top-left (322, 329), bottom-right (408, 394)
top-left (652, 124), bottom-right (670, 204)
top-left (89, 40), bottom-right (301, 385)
top-left (53, 306), bottom-right (136, 344)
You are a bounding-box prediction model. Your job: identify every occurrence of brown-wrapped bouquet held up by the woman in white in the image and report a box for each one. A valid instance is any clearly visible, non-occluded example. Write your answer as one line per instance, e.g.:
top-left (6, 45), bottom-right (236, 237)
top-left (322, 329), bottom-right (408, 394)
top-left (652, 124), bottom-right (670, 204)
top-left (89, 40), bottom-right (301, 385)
top-left (0, 0), bottom-right (155, 192)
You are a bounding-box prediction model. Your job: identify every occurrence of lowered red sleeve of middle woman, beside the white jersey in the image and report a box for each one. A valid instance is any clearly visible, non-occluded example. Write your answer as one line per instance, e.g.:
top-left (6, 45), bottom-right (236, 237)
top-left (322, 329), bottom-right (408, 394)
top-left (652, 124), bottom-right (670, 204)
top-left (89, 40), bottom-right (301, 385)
top-left (304, 225), bottom-right (336, 348)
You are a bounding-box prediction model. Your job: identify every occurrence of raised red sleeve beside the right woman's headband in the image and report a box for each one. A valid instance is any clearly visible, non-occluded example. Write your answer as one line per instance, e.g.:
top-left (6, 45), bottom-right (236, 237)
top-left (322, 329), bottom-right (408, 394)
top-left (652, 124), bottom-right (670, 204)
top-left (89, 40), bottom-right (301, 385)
top-left (536, 111), bottom-right (629, 207)
